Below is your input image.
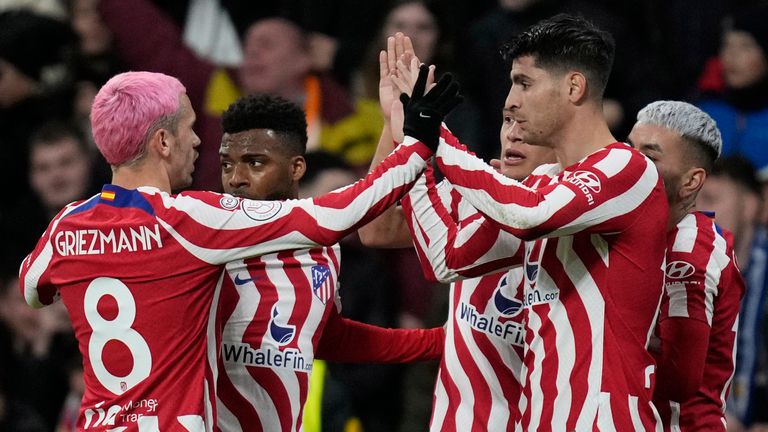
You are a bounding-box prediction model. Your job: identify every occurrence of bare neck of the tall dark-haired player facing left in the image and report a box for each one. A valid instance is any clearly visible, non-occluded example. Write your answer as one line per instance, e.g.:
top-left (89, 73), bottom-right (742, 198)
top-left (553, 112), bottom-right (616, 168)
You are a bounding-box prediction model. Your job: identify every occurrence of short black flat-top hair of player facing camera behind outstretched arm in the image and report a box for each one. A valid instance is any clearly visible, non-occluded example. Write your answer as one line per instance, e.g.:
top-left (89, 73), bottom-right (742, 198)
top-left (221, 94), bottom-right (307, 155)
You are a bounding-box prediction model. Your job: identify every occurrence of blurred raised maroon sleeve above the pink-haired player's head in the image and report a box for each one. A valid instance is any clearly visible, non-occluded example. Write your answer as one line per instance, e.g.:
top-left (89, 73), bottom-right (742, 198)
top-left (99, 0), bottom-right (214, 107)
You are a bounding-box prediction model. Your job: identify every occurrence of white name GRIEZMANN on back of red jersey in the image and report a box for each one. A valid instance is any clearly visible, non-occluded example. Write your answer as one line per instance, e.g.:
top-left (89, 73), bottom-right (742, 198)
top-left (53, 224), bottom-right (163, 256)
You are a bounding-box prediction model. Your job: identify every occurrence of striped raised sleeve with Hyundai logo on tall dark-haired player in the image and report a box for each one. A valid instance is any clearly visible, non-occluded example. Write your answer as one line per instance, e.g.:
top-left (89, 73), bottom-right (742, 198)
top-left (437, 126), bottom-right (667, 240)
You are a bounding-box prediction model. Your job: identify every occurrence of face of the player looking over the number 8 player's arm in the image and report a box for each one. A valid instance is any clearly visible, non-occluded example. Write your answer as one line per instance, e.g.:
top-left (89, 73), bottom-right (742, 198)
top-left (219, 129), bottom-right (304, 200)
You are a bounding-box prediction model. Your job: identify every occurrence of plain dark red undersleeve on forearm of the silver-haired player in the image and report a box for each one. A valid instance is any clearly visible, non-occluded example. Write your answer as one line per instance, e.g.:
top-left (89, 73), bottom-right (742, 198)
top-left (655, 318), bottom-right (710, 403)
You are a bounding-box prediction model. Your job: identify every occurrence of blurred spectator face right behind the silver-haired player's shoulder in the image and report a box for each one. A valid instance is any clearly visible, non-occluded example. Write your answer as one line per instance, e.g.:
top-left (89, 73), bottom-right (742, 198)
top-left (696, 176), bottom-right (759, 235)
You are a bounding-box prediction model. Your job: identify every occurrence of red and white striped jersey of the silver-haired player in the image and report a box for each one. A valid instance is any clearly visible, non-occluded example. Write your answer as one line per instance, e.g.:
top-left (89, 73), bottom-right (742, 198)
top-left (656, 212), bottom-right (744, 431)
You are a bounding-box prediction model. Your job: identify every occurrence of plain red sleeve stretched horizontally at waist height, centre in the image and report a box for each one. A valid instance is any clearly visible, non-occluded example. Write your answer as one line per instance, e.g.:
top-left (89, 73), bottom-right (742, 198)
top-left (315, 308), bottom-right (445, 363)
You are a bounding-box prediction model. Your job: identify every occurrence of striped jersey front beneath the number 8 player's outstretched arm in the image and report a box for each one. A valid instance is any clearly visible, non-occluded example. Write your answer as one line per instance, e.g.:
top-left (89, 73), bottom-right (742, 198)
top-left (217, 245), bottom-right (342, 432)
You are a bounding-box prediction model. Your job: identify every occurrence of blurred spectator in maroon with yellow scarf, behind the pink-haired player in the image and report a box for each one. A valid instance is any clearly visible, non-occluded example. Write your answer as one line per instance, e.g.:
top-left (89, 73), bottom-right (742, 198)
top-left (100, 0), bottom-right (381, 190)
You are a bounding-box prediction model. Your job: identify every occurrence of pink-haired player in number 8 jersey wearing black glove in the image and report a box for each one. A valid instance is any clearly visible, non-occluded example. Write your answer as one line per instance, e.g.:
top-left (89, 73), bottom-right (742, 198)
top-left (19, 72), bottom-right (460, 431)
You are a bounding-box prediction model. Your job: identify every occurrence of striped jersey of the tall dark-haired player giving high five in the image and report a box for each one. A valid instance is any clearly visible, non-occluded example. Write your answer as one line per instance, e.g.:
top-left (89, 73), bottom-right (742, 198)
top-left (437, 133), bottom-right (668, 431)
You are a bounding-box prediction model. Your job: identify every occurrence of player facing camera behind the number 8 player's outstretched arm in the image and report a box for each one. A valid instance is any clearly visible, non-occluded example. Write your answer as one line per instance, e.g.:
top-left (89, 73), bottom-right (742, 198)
top-left (217, 95), bottom-right (443, 432)
